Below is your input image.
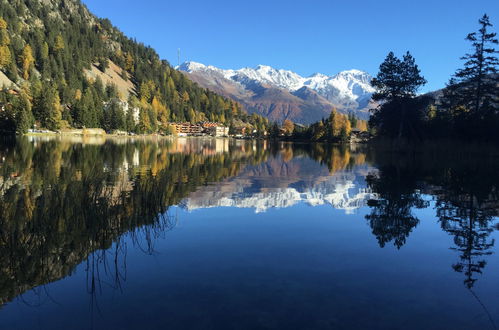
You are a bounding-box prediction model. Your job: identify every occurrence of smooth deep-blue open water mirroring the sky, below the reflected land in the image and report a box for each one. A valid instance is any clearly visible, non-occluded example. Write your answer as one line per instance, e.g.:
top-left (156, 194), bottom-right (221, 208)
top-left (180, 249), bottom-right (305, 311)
top-left (5, 204), bottom-right (499, 329)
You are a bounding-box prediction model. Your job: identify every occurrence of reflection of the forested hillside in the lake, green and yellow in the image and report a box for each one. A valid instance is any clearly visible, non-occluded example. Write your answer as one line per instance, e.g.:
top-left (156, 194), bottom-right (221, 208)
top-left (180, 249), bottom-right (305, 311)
top-left (0, 139), bottom-right (265, 304)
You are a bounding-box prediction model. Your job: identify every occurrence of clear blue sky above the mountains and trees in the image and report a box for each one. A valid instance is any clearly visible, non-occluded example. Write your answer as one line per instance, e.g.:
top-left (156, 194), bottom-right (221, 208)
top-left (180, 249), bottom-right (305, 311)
top-left (83, 0), bottom-right (499, 91)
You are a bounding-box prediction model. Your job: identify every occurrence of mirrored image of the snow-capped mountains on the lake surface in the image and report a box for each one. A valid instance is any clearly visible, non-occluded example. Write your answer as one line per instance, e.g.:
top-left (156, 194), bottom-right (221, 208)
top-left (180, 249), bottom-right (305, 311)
top-left (182, 144), bottom-right (376, 214)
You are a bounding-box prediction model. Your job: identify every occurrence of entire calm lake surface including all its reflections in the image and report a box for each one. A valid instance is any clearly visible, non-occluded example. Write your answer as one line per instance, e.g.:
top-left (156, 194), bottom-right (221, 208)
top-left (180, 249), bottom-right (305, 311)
top-left (0, 138), bottom-right (499, 329)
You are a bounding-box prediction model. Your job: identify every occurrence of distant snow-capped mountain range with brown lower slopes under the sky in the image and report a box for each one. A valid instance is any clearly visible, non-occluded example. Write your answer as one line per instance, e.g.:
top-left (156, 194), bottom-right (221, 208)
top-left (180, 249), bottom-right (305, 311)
top-left (178, 62), bottom-right (374, 123)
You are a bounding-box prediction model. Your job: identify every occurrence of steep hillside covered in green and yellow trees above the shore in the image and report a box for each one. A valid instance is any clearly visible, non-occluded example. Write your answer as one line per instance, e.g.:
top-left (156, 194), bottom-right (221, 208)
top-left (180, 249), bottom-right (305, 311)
top-left (0, 0), bottom-right (268, 133)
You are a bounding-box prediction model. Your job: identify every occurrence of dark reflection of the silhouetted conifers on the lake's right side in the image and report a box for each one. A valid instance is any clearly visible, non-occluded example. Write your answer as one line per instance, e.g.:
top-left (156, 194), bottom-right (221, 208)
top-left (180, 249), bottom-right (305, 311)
top-left (366, 150), bottom-right (499, 288)
